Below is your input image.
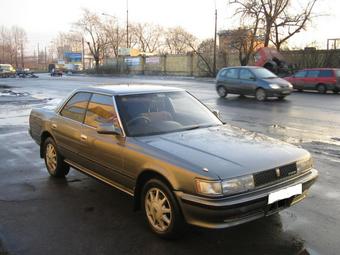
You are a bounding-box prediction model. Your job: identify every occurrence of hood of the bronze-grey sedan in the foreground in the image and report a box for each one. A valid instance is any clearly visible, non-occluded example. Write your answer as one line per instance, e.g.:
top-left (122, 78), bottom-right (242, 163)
top-left (136, 125), bottom-right (309, 179)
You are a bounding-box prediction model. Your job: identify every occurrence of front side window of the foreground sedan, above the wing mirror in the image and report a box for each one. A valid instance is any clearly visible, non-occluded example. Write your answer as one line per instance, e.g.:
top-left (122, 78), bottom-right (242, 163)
top-left (84, 94), bottom-right (118, 128)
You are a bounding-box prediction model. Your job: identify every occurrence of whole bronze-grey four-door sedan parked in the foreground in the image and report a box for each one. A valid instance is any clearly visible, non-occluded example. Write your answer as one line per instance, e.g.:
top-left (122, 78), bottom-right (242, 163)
top-left (29, 85), bottom-right (318, 237)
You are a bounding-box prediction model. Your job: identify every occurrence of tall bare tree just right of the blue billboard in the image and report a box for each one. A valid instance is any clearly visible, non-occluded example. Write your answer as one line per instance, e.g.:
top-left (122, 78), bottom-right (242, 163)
top-left (75, 9), bottom-right (107, 73)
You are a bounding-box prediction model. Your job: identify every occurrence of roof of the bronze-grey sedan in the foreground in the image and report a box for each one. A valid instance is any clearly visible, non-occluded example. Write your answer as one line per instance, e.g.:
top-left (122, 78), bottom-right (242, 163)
top-left (76, 84), bottom-right (185, 96)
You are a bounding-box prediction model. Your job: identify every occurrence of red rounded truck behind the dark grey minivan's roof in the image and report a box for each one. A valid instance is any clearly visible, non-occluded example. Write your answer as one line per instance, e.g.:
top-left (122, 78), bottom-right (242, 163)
top-left (253, 47), bottom-right (289, 76)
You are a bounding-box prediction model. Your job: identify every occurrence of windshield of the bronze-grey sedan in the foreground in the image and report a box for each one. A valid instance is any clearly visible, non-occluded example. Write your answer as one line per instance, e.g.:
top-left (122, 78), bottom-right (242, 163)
top-left (116, 91), bottom-right (222, 136)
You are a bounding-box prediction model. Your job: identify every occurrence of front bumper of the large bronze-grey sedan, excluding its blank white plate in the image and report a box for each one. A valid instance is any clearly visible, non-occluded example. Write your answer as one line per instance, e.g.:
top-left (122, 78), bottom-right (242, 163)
top-left (175, 169), bottom-right (318, 228)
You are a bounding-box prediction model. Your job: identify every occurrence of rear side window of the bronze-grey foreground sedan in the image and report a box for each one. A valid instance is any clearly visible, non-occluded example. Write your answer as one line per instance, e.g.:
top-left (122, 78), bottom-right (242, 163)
top-left (60, 92), bottom-right (91, 122)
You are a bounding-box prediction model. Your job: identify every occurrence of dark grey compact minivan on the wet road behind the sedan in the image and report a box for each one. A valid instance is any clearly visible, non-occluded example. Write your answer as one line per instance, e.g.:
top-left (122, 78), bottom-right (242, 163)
top-left (216, 66), bottom-right (293, 101)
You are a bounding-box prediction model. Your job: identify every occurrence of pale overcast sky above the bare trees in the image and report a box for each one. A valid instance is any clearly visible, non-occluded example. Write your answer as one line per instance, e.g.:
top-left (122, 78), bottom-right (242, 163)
top-left (0, 0), bottom-right (340, 50)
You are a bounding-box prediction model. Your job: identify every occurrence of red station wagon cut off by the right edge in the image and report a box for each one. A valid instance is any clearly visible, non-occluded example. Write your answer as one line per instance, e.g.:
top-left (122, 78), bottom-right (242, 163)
top-left (284, 68), bottom-right (340, 93)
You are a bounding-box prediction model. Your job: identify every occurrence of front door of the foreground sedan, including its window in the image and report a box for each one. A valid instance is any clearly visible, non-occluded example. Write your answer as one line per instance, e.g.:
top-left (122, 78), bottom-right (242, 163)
top-left (80, 94), bottom-right (128, 186)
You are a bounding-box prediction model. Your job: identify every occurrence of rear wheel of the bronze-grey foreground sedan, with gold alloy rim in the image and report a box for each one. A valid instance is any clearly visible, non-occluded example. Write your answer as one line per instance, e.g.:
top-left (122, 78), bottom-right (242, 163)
top-left (44, 137), bottom-right (70, 177)
